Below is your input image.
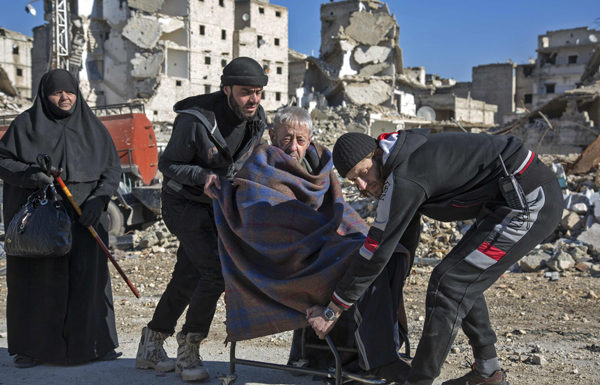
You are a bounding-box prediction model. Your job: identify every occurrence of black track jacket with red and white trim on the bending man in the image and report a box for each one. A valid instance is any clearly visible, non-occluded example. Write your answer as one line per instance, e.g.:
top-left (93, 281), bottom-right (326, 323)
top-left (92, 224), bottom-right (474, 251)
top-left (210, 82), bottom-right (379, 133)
top-left (333, 129), bottom-right (556, 307)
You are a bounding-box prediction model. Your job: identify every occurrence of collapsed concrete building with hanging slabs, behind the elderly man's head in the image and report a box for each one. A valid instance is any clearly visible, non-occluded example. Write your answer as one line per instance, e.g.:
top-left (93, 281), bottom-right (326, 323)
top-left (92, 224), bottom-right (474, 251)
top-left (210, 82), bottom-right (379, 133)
top-left (290, 0), bottom-right (497, 136)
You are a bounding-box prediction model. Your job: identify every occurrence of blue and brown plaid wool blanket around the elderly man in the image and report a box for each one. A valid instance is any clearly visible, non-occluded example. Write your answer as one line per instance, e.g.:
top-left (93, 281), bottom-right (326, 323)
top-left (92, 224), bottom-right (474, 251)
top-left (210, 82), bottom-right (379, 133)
top-left (214, 145), bottom-right (368, 341)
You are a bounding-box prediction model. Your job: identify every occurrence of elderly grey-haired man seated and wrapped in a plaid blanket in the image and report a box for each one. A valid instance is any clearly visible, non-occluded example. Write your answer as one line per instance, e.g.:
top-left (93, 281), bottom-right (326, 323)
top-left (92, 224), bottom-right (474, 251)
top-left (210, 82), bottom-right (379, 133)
top-left (212, 107), bottom-right (408, 381)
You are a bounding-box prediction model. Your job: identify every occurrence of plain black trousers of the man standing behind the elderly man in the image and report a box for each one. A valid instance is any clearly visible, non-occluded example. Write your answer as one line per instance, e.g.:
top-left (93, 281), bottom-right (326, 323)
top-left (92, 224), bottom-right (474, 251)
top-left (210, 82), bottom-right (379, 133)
top-left (148, 191), bottom-right (225, 335)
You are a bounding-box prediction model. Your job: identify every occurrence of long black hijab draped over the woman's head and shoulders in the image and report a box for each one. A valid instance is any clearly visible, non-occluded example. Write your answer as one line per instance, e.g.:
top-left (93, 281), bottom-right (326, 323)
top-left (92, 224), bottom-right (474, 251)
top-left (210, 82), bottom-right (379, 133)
top-left (0, 69), bottom-right (115, 182)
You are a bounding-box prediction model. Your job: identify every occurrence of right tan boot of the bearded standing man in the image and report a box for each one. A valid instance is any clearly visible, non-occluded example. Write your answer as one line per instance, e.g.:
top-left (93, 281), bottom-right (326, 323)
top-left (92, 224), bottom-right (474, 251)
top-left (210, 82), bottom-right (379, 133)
top-left (175, 333), bottom-right (210, 381)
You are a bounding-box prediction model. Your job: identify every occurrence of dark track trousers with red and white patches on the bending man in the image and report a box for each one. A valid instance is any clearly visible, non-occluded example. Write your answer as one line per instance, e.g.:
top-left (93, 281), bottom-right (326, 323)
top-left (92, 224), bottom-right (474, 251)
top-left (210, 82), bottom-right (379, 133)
top-left (408, 181), bottom-right (563, 385)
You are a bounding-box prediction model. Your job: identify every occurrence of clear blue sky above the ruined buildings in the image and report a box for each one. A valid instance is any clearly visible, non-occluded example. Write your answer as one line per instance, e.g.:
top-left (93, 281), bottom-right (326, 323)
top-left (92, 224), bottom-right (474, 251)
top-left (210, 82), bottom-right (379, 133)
top-left (0, 0), bottom-right (600, 81)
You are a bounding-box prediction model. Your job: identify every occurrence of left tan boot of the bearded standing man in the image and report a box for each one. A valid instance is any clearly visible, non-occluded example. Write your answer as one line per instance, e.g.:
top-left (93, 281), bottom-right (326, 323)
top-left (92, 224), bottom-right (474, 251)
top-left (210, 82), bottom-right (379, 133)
top-left (135, 327), bottom-right (175, 372)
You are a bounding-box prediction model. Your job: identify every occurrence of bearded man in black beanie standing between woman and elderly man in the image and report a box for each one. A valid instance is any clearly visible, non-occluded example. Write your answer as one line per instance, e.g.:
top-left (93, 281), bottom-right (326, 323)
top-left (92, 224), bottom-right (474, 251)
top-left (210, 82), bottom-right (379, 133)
top-left (136, 57), bottom-right (268, 381)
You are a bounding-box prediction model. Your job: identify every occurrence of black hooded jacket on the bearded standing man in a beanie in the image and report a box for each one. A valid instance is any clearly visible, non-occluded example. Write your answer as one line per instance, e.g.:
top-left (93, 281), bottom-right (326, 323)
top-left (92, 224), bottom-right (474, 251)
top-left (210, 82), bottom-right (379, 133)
top-left (158, 91), bottom-right (266, 204)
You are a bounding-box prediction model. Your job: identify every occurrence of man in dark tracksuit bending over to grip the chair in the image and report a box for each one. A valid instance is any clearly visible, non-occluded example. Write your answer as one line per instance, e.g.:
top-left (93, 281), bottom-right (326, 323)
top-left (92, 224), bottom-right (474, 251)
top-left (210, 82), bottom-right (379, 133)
top-left (309, 129), bottom-right (563, 385)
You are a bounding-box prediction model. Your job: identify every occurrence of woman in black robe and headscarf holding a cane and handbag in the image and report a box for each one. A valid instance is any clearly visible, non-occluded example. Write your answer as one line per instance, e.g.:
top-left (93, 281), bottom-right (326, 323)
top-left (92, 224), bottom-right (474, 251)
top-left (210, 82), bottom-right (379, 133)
top-left (0, 70), bottom-right (121, 367)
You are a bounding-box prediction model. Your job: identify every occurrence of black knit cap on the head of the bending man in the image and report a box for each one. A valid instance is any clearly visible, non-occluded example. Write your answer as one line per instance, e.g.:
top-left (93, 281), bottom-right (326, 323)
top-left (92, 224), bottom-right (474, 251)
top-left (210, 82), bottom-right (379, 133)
top-left (333, 132), bottom-right (377, 178)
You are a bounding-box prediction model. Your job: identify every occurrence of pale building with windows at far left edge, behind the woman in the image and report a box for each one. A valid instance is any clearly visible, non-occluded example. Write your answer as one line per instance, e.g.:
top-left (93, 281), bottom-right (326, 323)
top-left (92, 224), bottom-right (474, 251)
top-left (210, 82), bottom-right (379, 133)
top-left (0, 27), bottom-right (33, 98)
